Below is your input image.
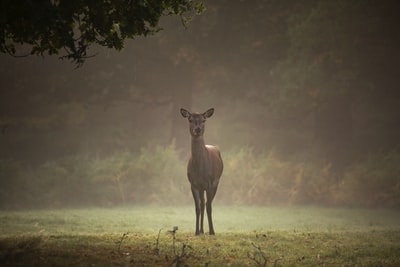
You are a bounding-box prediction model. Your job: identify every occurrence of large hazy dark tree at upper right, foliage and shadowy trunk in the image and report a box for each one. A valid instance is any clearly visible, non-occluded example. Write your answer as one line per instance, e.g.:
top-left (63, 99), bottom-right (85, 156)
top-left (267, 0), bottom-right (400, 179)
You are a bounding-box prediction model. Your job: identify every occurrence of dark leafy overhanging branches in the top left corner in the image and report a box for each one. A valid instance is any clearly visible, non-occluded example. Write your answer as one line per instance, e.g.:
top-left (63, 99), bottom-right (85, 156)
top-left (0, 0), bottom-right (204, 65)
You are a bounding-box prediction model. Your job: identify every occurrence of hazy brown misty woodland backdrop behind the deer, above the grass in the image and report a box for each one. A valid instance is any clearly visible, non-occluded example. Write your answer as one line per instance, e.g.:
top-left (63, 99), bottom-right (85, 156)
top-left (0, 0), bottom-right (400, 209)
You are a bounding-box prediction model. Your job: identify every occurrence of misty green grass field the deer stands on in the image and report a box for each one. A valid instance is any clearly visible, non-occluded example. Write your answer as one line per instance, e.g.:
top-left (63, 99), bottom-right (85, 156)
top-left (0, 205), bottom-right (400, 266)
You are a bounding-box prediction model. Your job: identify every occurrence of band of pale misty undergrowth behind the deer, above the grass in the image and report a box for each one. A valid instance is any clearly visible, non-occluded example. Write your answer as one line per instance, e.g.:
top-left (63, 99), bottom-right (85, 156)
top-left (0, 144), bottom-right (400, 209)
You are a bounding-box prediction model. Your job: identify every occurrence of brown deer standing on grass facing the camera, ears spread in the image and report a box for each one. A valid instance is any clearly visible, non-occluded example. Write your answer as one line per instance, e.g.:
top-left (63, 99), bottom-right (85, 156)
top-left (181, 108), bottom-right (224, 235)
